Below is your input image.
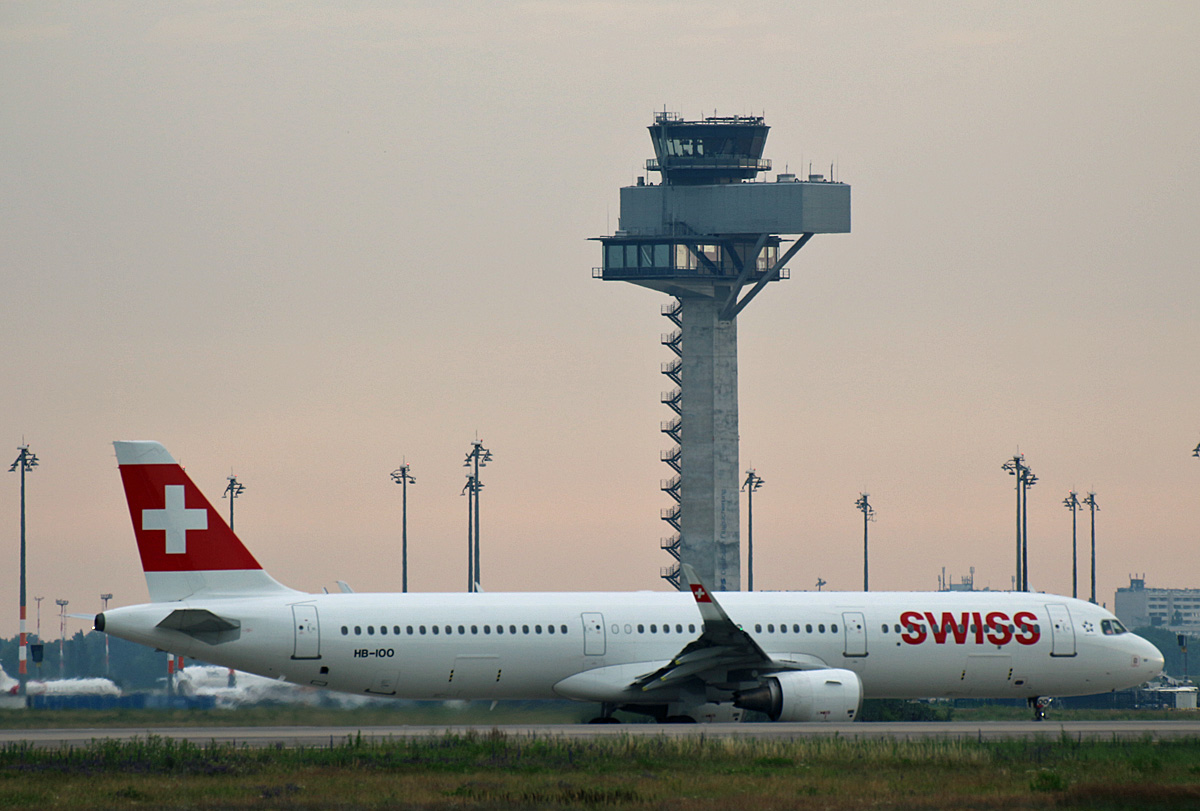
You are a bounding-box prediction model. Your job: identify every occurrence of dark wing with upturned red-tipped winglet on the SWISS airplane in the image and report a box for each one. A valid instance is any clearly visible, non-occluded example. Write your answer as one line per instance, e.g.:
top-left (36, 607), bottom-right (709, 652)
top-left (630, 564), bottom-right (796, 690)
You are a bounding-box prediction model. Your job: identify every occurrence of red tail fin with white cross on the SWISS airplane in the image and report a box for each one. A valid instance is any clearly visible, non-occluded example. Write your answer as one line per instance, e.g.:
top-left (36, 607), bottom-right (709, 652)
top-left (113, 441), bottom-right (295, 601)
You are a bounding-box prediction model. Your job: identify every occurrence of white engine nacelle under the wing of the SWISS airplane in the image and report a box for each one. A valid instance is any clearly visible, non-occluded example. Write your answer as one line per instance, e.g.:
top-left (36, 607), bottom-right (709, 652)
top-left (733, 668), bottom-right (863, 722)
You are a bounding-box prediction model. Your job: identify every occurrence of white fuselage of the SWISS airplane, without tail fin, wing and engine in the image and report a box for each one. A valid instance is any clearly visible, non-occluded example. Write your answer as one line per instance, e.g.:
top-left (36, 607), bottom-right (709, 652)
top-left (104, 591), bottom-right (1163, 702)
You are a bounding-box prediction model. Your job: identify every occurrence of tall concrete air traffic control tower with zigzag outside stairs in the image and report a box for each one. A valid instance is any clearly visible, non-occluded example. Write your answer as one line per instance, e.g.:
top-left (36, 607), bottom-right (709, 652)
top-left (593, 113), bottom-right (850, 591)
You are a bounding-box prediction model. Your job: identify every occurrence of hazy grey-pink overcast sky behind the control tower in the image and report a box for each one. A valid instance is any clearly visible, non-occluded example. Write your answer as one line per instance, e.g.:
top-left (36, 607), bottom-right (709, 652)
top-left (0, 0), bottom-right (1200, 637)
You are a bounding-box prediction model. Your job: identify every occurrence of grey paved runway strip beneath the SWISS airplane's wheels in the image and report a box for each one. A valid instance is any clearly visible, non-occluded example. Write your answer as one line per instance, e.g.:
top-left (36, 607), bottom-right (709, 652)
top-left (0, 717), bottom-right (1200, 747)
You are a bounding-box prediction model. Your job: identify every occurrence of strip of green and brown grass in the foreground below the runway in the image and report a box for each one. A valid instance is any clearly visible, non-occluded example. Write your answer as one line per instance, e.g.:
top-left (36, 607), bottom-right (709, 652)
top-left (0, 732), bottom-right (1200, 811)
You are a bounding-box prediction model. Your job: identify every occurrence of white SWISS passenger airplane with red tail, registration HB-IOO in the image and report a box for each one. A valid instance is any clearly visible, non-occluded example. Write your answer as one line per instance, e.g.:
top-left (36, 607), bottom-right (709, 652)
top-left (95, 441), bottom-right (1163, 722)
